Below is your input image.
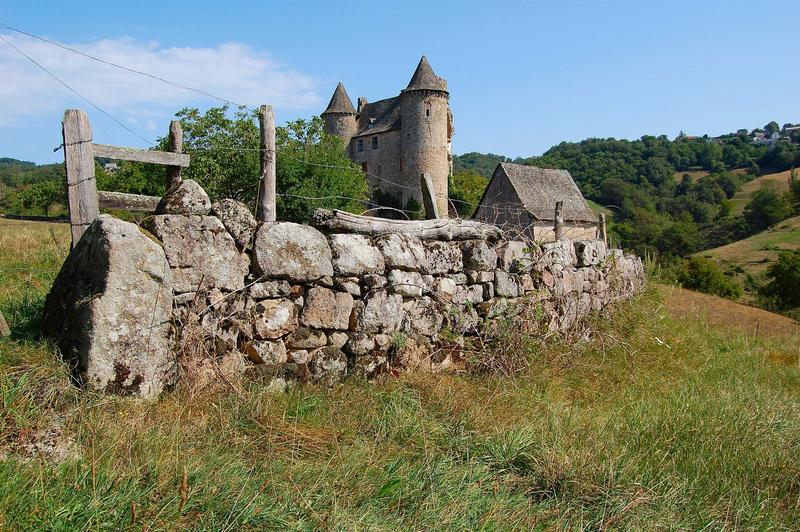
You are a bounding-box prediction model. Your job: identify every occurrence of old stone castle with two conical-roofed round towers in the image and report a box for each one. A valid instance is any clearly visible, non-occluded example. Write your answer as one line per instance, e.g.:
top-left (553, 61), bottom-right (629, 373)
top-left (321, 56), bottom-right (453, 215)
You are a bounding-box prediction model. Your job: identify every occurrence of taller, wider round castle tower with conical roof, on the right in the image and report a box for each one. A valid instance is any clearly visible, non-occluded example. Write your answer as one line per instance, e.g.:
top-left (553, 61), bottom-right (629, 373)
top-left (400, 56), bottom-right (452, 216)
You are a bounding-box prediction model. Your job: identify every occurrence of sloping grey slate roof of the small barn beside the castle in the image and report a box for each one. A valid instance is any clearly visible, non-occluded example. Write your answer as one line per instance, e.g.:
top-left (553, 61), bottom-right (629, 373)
top-left (481, 163), bottom-right (597, 222)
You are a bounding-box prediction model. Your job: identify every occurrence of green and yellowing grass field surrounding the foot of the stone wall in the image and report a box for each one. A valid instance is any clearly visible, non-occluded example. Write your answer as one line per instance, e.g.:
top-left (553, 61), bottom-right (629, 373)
top-left (0, 220), bottom-right (800, 530)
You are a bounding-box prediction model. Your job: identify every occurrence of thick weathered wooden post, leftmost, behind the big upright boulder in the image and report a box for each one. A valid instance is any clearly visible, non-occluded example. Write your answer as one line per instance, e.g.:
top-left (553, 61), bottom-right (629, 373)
top-left (61, 109), bottom-right (100, 247)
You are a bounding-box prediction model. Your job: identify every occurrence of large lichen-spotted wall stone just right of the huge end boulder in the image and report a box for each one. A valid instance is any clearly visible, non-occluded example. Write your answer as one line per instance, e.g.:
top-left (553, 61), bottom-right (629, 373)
top-left (148, 214), bottom-right (248, 293)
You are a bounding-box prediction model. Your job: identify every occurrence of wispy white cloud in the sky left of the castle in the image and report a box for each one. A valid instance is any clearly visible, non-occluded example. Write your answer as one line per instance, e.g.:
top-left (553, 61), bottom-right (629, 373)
top-left (0, 34), bottom-right (322, 129)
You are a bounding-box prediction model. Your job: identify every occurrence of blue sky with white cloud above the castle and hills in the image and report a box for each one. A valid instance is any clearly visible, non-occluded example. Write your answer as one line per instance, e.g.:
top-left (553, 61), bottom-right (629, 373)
top-left (0, 0), bottom-right (800, 163)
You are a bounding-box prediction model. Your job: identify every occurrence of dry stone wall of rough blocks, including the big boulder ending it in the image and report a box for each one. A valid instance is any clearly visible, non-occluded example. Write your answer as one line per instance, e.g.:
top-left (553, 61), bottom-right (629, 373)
top-left (45, 181), bottom-right (644, 397)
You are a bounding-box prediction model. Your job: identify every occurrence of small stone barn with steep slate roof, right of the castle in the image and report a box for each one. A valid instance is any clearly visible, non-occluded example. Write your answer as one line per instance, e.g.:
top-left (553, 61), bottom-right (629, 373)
top-left (472, 163), bottom-right (597, 242)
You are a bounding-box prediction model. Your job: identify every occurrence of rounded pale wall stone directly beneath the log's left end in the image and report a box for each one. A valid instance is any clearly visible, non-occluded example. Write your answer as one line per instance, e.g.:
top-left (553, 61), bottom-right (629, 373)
top-left (253, 222), bottom-right (333, 283)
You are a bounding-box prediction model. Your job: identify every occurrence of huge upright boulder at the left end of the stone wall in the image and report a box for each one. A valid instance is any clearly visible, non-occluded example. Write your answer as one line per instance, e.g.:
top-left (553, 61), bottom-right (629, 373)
top-left (43, 215), bottom-right (173, 398)
